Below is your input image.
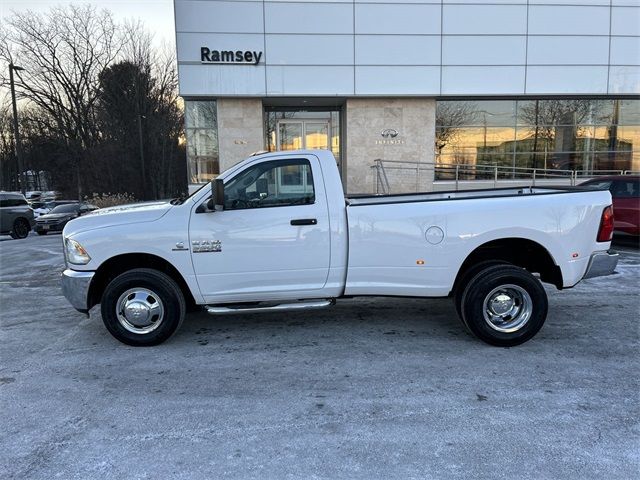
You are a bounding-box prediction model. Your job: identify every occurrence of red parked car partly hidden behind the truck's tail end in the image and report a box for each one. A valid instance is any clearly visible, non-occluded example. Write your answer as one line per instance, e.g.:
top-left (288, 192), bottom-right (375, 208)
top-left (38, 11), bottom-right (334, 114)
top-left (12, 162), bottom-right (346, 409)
top-left (580, 175), bottom-right (640, 236)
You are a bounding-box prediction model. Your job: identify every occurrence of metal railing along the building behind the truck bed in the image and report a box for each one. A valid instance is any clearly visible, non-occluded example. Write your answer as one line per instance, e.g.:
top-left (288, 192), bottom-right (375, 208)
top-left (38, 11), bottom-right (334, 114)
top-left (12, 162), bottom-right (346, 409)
top-left (371, 158), bottom-right (640, 194)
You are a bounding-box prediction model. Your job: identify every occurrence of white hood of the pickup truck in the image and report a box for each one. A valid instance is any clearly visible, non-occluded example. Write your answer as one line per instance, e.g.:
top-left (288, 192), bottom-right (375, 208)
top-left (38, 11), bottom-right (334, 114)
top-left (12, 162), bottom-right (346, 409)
top-left (63, 200), bottom-right (172, 236)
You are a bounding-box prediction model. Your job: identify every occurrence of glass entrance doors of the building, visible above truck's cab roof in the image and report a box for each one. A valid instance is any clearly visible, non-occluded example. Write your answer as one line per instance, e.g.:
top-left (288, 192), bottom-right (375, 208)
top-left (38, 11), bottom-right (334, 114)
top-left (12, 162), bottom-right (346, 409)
top-left (277, 119), bottom-right (331, 150)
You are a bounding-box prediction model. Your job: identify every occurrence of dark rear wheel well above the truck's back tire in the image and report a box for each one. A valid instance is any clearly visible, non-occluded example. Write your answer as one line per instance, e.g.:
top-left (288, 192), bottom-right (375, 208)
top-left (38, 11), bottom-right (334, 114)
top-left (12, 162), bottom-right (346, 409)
top-left (452, 238), bottom-right (562, 291)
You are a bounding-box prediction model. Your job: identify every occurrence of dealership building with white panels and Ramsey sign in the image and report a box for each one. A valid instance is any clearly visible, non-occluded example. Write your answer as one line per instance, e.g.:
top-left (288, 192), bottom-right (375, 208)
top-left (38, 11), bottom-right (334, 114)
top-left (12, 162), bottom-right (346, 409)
top-left (174, 0), bottom-right (640, 193)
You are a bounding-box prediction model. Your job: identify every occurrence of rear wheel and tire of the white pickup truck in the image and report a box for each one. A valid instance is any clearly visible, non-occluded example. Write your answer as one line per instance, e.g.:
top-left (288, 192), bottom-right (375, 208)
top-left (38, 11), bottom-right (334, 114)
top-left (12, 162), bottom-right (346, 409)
top-left (461, 265), bottom-right (548, 347)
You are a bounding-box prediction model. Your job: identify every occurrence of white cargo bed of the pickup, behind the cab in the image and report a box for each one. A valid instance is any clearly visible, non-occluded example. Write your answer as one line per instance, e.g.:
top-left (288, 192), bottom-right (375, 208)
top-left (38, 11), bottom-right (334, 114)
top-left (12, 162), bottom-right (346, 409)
top-left (345, 187), bottom-right (611, 296)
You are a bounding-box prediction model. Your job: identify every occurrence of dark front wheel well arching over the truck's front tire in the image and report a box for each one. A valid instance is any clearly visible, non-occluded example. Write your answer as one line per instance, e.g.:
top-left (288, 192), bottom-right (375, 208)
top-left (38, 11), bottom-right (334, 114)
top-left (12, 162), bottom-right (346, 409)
top-left (88, 253), bottom-right (196, 309)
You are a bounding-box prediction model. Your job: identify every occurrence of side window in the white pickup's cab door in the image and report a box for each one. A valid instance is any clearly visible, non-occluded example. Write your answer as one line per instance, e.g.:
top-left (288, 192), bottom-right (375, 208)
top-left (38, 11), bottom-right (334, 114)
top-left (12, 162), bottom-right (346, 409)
top-left (224, 159), bottom-right (315, 210)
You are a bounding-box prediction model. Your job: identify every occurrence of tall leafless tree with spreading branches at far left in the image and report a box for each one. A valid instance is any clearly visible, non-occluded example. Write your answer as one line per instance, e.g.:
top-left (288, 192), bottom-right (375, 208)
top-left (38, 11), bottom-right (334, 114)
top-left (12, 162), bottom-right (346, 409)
top-left (0, 5), bottom-right (122, 197)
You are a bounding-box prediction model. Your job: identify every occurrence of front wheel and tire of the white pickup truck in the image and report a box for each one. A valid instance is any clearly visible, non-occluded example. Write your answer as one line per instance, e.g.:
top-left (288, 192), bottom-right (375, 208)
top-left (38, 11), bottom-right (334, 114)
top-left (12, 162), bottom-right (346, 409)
top-left (100, 268), bottom-right (186, 347)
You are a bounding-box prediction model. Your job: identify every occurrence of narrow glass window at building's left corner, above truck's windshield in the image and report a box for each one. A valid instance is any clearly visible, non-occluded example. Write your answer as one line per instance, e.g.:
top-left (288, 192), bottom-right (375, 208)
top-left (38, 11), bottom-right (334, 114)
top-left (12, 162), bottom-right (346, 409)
top-left (185, 100), bottom-right (220, 183)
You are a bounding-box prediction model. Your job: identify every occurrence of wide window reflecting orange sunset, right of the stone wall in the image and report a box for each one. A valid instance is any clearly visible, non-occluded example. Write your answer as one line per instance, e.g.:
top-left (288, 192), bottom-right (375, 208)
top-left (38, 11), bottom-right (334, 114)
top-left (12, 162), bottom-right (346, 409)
top-left (435, 99), bottom-right (640, 178)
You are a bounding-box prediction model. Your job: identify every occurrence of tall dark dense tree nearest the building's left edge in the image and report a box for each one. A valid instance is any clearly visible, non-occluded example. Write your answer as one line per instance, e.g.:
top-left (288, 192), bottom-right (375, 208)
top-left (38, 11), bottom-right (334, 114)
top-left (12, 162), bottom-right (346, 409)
top-left (99, 22), bottom-right (186, 198)
